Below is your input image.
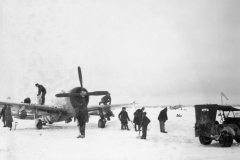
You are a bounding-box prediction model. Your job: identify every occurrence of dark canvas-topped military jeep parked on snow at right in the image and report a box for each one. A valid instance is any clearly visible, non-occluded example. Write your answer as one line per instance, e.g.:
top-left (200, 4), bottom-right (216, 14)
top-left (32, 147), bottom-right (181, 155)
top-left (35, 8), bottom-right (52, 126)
top-left (194, 104), bottom-right (240, 147)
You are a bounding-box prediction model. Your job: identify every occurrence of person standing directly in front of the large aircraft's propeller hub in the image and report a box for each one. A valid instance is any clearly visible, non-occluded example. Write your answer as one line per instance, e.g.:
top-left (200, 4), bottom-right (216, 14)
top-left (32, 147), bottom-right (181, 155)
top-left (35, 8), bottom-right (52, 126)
top-left (76, 108), bottom-right (88, 138)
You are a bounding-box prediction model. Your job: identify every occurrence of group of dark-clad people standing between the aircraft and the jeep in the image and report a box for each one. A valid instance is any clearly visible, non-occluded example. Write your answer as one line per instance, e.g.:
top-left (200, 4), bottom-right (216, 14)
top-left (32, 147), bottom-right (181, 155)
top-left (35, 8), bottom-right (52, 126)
top-left (118, 107), bottom-right (168, 139)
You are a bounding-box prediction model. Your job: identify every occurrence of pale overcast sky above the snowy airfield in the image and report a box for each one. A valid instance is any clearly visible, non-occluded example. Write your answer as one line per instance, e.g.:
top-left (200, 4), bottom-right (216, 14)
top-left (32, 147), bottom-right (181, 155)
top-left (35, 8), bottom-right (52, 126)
top-left (0, 0), bottom-right (240, 105)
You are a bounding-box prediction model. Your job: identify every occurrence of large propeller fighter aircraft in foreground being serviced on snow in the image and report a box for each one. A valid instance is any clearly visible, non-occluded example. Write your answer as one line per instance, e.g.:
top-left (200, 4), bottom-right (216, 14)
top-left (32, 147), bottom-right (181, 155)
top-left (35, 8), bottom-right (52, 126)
top-left (0, 67), bottom-right (132, 129)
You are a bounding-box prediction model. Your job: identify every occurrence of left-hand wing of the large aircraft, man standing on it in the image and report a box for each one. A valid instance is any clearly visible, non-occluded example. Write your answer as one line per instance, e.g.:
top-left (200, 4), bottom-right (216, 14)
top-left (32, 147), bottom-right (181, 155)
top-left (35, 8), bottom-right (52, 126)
top-left (0, 101), bottom-right (66, 112)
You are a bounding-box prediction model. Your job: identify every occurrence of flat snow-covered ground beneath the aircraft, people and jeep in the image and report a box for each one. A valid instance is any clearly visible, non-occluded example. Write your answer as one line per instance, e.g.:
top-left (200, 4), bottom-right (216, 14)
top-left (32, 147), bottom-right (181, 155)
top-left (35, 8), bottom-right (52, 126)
top-left (0, 107), bottom-right (240, 160)
